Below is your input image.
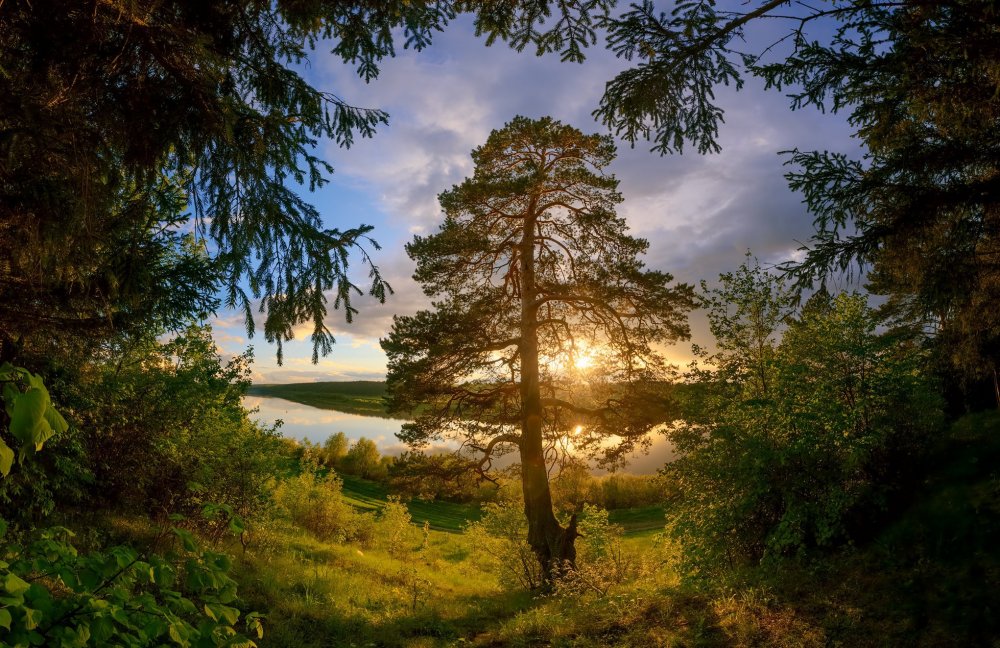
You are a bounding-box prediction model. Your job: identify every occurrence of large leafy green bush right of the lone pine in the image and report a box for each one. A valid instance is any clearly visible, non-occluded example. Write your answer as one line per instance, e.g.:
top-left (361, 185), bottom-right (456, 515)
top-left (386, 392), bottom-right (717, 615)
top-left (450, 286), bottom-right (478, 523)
top-left (665, 256), bottom-right (941, 570)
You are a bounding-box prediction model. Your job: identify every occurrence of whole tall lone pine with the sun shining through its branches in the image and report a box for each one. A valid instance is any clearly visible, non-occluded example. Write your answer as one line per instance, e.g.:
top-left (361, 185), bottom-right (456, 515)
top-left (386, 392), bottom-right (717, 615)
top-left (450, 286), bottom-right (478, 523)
top-left (382, 117), bottom-right (693, 570)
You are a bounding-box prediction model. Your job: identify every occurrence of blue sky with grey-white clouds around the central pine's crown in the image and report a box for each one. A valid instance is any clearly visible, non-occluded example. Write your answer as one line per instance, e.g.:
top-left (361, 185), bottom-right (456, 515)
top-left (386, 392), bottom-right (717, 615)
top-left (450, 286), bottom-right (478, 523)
top-left (213, 7), bottom-right (858, 383)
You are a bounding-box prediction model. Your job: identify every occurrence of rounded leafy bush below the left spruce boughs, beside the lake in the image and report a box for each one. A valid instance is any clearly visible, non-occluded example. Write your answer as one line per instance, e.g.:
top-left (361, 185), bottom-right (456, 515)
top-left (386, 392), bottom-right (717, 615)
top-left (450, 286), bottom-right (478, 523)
top-left (65, 325), bottom-right (282, 522)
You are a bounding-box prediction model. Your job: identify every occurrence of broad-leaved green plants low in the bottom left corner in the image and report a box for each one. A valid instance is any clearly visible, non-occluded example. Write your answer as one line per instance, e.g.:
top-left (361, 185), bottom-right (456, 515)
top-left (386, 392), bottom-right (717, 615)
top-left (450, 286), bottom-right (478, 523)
top-left (0, 520), bottom-right (263, 647)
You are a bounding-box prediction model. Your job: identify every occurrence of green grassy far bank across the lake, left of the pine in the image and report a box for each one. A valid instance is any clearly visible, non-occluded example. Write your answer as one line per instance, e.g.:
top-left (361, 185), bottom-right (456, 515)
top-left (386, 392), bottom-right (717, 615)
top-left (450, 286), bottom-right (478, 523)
top-left (247, 380), bottom-right (400, 418)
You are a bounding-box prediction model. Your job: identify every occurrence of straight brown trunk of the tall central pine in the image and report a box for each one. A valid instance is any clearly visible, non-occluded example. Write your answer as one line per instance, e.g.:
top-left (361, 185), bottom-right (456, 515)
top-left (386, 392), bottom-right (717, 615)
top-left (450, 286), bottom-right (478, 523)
top-left (520, 201), bottom-right (579, 584)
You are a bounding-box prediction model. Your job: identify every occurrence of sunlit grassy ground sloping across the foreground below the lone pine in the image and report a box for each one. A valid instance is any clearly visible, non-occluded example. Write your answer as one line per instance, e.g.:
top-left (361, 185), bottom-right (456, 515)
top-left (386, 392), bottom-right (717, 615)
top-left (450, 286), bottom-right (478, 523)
top-left (219, 416), bottom-right (1000, 648)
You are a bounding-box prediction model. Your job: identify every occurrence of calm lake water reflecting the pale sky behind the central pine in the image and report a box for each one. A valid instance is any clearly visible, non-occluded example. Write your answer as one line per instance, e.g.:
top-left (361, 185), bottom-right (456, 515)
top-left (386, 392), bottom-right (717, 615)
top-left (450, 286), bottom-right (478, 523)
top-left (243, 396), bottom-right (674, 474)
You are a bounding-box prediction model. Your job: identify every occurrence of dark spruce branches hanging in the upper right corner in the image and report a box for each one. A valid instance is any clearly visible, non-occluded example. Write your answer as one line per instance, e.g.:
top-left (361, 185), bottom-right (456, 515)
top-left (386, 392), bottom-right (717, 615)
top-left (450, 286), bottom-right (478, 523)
top-left (595, 0), bottom-right (1000, 390)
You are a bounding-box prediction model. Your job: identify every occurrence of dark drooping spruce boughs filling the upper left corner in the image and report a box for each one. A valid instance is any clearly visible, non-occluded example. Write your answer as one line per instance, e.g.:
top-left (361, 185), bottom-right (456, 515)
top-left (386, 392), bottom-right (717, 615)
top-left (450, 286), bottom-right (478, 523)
top-left (0, 0), bottom-right (611, 360)
